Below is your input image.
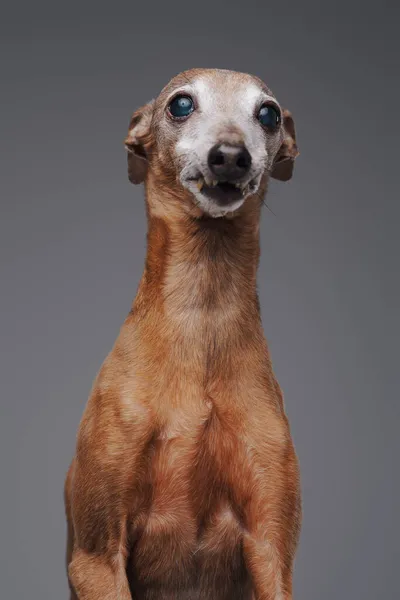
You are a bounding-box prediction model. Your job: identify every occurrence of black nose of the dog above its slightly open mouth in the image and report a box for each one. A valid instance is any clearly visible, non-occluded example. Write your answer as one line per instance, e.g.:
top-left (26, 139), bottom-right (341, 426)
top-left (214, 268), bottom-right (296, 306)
top-left (208, 144), bottom-right (251, 181)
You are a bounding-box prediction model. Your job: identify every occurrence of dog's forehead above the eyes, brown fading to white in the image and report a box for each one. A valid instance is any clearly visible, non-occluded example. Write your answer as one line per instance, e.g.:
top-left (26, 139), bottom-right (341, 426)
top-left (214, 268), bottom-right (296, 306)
top-left (156, 69), bottom-right (278, 112)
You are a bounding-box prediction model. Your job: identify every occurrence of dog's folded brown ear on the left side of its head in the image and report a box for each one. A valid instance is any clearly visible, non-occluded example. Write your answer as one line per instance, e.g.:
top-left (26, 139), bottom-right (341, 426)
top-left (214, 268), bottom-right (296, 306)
top-left (125, 100), bottom-right (154, 183)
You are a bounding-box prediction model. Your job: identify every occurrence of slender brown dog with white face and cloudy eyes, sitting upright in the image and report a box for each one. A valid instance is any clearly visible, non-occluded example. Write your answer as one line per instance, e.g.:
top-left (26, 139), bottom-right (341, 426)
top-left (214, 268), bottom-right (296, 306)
top-left (65, 69), bottom-right (301, 600)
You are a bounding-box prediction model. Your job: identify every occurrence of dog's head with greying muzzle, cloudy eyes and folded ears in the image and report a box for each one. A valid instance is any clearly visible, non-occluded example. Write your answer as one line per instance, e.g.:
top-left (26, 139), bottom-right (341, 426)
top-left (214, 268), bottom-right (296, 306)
top-left (125, 69), bottom-right (298, 217)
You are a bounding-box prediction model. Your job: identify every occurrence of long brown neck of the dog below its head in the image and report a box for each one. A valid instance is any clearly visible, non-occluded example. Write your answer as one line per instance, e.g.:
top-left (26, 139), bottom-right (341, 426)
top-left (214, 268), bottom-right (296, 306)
top-left (126, 186), bottom-right (264, 384)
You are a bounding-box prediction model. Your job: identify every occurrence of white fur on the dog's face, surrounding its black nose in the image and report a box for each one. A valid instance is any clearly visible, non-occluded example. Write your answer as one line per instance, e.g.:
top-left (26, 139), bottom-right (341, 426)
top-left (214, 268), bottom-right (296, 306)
top-left (174, 77), bottom-right (277, 216)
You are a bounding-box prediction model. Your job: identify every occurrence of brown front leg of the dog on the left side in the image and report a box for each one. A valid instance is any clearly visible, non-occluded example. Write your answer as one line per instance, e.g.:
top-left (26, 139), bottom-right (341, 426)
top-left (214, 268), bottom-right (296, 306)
top-left (68, 382), bottom-right (152, 600)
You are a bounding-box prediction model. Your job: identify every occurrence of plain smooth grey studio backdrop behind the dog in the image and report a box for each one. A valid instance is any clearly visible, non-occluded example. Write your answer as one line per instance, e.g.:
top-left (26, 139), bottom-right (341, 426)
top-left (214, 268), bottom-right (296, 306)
top-left (0, 0), bottom-right (400, 600)
